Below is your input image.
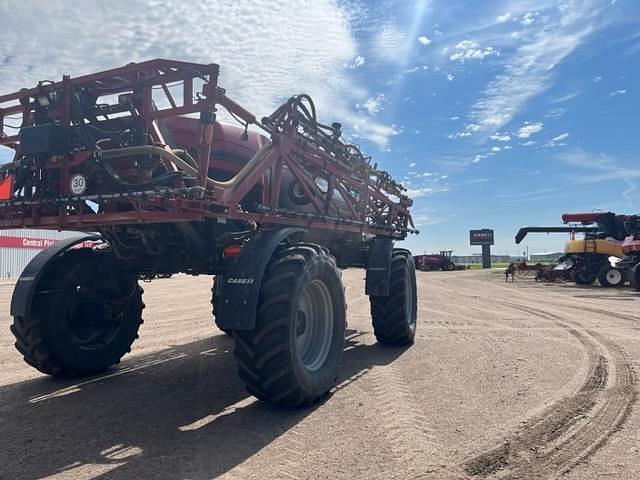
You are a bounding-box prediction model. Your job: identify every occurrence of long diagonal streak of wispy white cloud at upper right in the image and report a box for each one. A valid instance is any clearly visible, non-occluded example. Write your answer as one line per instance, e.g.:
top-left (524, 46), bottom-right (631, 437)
top-left (469, 1), bottom-right (605, 135)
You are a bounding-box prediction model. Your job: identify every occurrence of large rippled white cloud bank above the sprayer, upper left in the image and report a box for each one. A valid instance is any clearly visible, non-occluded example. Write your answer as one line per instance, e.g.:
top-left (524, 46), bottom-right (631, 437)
top-left (0, 0), bottom-right (404, 150)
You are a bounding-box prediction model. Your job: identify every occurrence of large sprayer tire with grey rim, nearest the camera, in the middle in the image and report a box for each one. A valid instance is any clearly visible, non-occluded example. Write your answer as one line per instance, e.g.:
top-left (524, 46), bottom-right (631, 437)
top-left (233, 243), bottom-right (346, 407)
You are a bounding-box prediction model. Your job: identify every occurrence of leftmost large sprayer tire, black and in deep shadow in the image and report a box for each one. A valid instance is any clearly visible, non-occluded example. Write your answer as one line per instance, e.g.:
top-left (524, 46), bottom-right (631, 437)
top-left (11, 248), bottom-right (144, 377)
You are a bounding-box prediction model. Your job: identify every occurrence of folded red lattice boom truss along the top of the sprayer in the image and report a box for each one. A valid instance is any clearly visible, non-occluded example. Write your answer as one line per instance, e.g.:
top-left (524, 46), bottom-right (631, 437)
top-left (0, 60), bottom-right (414, 238)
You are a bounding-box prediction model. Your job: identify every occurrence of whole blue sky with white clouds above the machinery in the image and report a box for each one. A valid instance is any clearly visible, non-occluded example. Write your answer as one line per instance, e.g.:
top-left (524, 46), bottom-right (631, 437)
top-left (0, 0), bottom-right (640, 254)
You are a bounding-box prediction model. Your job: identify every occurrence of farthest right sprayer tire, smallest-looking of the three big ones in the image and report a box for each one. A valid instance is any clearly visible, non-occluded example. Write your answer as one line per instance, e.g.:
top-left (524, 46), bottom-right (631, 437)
top-left (369, 250), bottom-right (418, 345)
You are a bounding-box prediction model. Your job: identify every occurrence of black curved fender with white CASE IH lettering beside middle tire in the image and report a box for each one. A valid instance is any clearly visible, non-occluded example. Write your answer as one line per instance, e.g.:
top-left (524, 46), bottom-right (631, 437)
top-left (216, 227), bottom-right (306, 330)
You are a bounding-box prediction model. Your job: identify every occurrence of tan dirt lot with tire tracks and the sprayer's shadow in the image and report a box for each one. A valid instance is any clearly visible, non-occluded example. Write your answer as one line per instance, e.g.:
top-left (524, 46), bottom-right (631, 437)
top-left (0, 270), bottom-right (640, 480)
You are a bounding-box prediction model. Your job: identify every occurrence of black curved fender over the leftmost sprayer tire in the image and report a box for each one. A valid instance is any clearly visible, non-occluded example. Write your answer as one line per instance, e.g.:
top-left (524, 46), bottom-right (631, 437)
top-left (11, 233), bottom-right (102, 317)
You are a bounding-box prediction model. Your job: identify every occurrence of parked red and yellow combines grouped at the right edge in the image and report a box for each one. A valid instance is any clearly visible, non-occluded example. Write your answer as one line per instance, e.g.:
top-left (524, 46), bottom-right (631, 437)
top-left (515, 212), bottom-right (640, 290)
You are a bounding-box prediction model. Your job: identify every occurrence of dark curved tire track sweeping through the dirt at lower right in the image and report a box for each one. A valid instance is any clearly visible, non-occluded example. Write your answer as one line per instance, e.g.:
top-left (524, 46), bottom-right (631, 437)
top-left (463, 299), bottom-right (637, 479)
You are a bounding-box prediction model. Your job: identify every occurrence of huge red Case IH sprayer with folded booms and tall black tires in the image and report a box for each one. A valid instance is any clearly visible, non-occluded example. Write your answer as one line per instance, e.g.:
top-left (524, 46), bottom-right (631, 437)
top-left (0, 60), bottom-right (417, 406)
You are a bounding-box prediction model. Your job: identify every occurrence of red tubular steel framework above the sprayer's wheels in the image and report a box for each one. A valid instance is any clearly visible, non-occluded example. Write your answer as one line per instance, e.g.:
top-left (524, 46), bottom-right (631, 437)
top-left (0, 60), bottom-right (414, 238)
